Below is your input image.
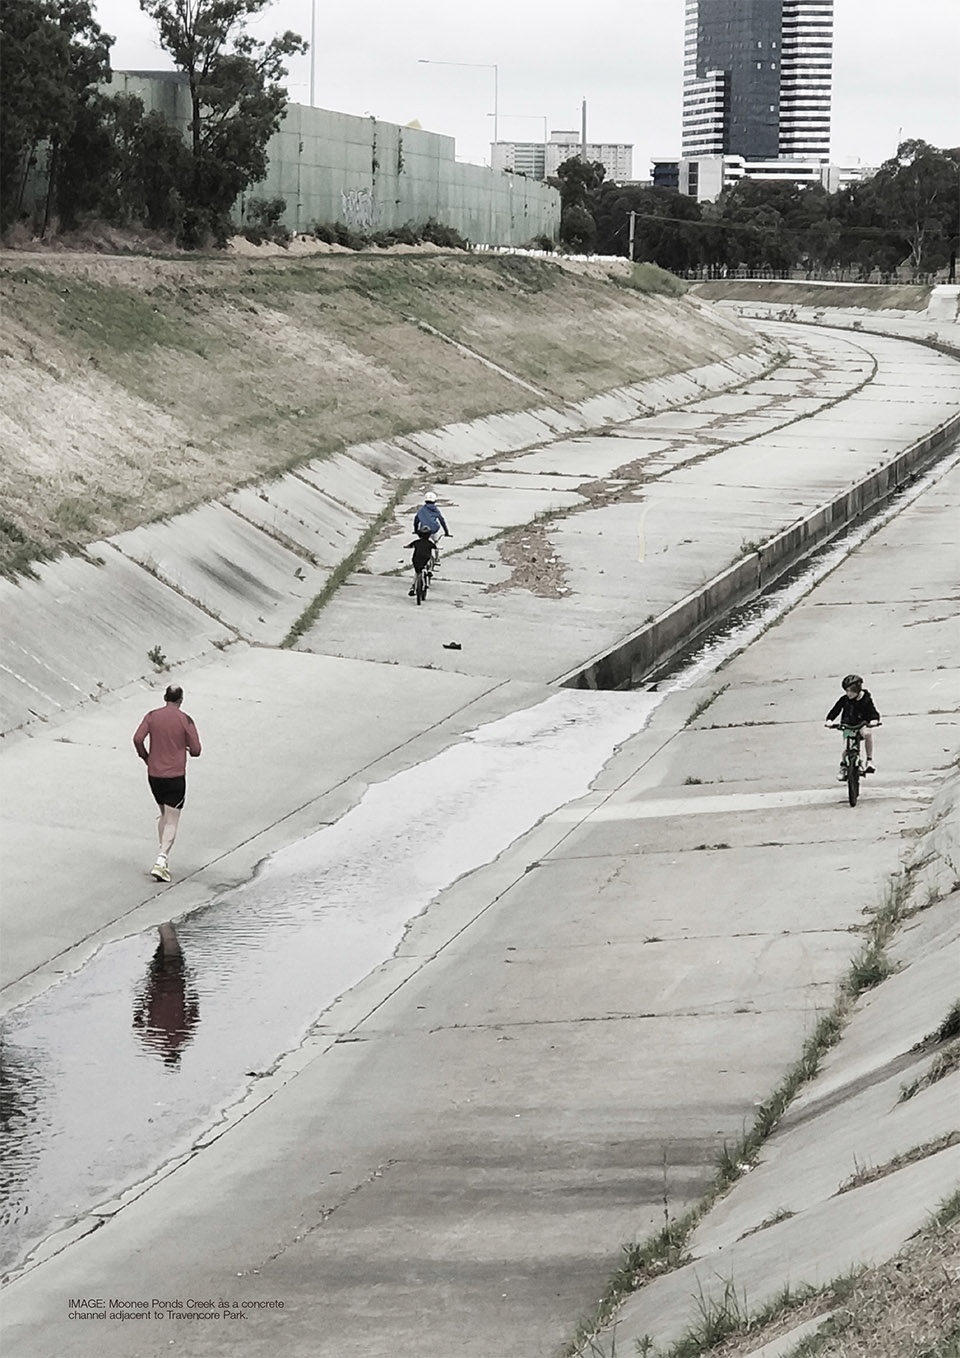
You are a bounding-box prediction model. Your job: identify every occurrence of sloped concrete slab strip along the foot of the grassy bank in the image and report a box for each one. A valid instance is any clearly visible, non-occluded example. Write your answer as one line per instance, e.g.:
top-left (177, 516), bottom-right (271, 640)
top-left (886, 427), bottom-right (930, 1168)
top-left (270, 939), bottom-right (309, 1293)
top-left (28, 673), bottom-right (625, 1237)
top-left (0, 342), bottom-right (778, 733)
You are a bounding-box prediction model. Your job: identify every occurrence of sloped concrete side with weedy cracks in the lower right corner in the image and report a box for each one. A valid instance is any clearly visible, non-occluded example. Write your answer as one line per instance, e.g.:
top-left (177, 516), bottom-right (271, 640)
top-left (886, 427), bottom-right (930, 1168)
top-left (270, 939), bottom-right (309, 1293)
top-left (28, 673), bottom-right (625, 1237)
top-left (593, 775), bottom-right (960, 1355)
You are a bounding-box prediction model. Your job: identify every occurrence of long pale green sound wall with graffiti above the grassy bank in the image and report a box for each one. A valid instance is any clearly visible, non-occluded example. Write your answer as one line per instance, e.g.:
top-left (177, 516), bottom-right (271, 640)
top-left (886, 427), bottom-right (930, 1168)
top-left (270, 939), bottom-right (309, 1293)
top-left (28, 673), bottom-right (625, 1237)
top-left (110, 71), bottom-right (559, 246)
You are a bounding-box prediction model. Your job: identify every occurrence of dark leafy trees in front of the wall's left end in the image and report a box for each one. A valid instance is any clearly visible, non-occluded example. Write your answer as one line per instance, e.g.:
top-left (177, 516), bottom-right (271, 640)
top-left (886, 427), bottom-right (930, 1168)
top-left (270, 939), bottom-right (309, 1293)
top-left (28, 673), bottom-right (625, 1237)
top-left (0, 0), bottom-right (307, 246)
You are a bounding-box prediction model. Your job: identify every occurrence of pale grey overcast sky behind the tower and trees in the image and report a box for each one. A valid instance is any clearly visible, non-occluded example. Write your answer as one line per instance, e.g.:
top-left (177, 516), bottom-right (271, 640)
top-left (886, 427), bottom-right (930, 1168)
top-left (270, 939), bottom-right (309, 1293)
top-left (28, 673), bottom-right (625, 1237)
top-left (95, 0), bottom-right (960, 179)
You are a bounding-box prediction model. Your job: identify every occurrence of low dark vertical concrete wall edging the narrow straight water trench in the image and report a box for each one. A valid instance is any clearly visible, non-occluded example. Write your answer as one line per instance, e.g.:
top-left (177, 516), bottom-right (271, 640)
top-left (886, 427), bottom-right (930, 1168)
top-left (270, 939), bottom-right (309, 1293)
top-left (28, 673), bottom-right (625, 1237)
top-left (555, 414), bottom-right (960, 689)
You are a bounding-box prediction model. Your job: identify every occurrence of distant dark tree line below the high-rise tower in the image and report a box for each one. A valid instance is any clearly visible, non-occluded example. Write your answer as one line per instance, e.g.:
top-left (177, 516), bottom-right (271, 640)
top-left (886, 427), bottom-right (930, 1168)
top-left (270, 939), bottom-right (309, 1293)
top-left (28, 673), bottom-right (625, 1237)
top-left (554, 140), bottom-right (960, 278)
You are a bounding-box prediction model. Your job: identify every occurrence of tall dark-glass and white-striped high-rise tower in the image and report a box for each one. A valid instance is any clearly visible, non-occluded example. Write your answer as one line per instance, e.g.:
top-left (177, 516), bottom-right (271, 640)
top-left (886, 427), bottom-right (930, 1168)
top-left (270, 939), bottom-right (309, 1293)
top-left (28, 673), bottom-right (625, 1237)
top-left (683, 0), bottom-right (834, 160)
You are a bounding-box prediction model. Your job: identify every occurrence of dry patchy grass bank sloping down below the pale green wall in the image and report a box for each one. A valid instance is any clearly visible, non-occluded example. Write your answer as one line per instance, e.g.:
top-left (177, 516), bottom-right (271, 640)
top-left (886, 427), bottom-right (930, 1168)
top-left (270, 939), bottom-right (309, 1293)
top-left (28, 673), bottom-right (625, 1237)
top-left (0, 251), bottom-right (755, 573)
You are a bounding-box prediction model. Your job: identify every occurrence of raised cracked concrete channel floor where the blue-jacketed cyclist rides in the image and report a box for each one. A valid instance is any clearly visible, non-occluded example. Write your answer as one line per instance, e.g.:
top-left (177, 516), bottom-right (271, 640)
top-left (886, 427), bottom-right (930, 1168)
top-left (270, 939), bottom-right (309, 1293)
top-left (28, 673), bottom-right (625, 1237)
top-left (305, 326), bottom-right (960, 682)
